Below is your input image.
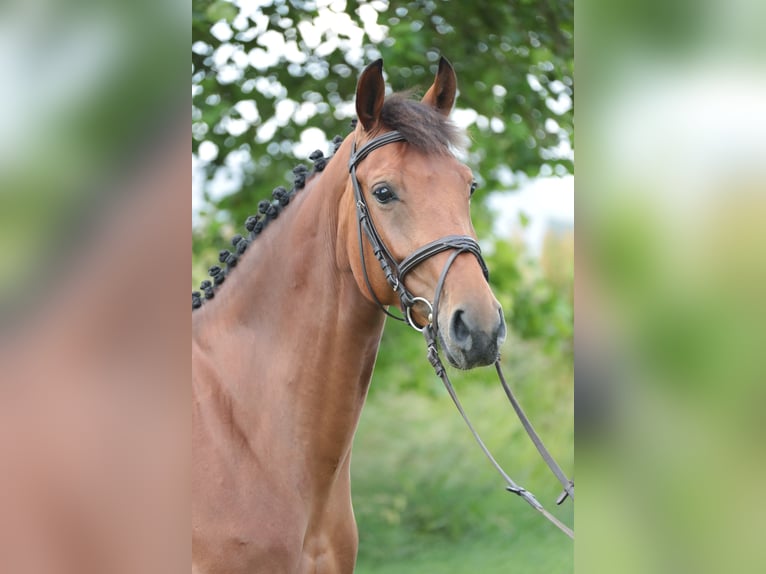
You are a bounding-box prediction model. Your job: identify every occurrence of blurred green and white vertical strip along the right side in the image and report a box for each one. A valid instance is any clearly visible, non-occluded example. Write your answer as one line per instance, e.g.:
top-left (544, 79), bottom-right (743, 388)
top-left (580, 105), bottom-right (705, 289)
top-left (575, 0), bottom-right (766, 574)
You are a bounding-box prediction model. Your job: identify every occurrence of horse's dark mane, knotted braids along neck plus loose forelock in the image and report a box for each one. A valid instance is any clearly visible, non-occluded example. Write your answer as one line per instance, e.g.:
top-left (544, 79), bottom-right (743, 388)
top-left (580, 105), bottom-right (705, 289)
top-left (192, 92), bottom-right (464, 310)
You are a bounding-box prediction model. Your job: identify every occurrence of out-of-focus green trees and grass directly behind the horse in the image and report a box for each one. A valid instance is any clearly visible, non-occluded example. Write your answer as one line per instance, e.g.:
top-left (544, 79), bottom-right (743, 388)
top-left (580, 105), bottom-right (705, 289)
top-left (192, 0), bottom-right (574, 573)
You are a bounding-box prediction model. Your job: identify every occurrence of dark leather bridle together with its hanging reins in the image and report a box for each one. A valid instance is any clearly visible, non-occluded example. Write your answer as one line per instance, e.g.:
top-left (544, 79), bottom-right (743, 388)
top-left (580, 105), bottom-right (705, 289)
top-left (348, 131), bottom-right (574, 539)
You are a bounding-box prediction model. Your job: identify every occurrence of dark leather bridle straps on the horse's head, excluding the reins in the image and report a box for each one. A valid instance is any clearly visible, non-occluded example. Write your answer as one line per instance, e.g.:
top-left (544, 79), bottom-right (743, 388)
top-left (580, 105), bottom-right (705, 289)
top-left (348, 131), bottom-right (489, 332)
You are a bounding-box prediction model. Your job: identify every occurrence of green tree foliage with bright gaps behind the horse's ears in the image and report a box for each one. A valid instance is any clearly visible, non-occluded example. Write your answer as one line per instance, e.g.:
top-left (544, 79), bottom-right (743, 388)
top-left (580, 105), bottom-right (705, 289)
top-left (192, 0), bottom-right (573, 219)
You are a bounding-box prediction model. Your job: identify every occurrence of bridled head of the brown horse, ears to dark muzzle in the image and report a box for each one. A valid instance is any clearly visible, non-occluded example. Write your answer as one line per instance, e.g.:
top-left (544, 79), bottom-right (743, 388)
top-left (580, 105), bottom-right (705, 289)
top-left (341, 58), bottom-right (506, 369)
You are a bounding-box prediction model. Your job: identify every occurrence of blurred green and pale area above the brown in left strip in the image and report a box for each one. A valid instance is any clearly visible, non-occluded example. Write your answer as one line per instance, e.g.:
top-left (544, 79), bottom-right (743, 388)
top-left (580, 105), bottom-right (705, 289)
top-left (0, 0), bottom-right (186, 310)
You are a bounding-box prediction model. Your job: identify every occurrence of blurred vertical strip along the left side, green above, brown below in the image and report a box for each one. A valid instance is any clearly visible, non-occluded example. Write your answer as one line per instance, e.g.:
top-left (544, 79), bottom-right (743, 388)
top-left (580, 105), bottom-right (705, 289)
top-left (0, 0), bottom-right (191, 574)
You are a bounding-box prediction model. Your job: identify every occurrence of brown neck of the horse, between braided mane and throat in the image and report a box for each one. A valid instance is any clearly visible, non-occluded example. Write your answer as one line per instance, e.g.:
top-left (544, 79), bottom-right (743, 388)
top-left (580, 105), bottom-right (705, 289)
top-left (197, 141), bottom-right (384, 486)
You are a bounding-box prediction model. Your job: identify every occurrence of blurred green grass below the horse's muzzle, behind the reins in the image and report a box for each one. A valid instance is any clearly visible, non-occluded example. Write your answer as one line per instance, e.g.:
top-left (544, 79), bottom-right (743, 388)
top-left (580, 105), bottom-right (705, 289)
top-left (352, 340), bottom-right (574, 574)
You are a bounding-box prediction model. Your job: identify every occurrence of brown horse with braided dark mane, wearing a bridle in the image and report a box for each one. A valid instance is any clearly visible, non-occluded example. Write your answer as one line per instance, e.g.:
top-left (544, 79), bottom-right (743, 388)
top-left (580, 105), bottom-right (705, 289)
top-left (192, 59), bottom-right (505, 574)
